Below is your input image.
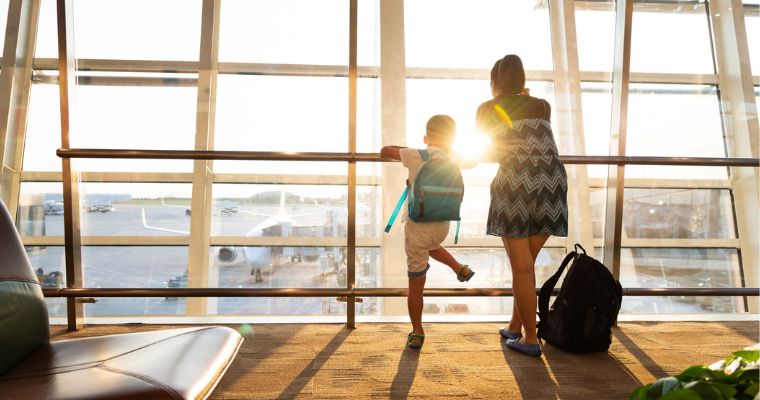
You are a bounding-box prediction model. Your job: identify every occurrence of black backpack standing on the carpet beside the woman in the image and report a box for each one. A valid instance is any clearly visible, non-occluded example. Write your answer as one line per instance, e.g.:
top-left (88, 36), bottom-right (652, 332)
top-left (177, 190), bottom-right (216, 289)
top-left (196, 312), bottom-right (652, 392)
top-left (538, 244), bottom-right (623, 352)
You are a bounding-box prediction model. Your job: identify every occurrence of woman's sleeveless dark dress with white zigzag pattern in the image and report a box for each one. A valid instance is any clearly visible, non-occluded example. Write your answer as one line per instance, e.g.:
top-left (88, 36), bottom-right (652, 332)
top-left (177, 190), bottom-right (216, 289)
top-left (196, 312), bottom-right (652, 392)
top-left (478, 96), bottom-right (567, 238)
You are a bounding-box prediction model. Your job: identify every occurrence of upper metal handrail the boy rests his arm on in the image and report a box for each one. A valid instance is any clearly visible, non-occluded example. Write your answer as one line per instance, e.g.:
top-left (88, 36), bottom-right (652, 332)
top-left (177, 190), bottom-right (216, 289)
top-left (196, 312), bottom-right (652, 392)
top-left (55, 148), bottom-right (760, 167)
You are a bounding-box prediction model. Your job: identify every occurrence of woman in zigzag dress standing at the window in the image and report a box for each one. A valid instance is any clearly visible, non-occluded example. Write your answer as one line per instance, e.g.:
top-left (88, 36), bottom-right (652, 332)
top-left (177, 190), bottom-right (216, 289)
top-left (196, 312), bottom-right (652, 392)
top-left (477, 54), bottom-right (567, 357)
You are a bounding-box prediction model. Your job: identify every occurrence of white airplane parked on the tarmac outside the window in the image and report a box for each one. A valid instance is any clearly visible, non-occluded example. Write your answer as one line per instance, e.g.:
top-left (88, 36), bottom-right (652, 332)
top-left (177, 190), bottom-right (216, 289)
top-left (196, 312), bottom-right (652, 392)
top-left (142, 191), bottom-right (345, 286)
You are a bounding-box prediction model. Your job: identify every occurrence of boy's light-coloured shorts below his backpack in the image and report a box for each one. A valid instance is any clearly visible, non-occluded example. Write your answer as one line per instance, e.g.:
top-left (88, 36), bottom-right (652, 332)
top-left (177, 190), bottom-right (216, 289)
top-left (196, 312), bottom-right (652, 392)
top-left (404, 219), bottom-right (449, 278)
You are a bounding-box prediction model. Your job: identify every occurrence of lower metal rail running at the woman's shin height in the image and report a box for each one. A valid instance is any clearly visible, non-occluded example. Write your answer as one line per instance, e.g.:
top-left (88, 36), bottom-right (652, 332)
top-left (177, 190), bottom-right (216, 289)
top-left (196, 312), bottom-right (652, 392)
top-left (42, 288), bottom-right (760, 297)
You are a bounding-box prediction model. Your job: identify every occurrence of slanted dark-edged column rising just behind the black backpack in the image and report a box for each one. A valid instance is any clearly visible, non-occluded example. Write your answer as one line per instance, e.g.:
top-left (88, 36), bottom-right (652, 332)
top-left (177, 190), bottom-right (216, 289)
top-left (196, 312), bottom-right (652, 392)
top-left (604, 0), bottom-right (633, 279)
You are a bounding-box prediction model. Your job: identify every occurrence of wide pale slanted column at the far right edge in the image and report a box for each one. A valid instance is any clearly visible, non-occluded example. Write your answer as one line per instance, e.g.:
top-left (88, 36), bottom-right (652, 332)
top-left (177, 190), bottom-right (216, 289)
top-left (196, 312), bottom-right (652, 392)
top-left (709, 0), bottom-right (760, 313)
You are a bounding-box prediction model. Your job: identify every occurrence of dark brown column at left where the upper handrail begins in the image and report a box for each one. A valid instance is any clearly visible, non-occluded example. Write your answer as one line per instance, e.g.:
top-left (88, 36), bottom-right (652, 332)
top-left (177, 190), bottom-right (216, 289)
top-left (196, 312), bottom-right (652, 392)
top-left (57, 0), bottom-right (84, 330)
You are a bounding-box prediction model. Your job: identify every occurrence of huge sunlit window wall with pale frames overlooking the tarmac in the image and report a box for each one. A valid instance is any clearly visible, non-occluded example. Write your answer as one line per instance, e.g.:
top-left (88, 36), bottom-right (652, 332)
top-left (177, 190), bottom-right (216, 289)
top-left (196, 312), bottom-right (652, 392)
top-left (0, 0), bottom-right (760, 321)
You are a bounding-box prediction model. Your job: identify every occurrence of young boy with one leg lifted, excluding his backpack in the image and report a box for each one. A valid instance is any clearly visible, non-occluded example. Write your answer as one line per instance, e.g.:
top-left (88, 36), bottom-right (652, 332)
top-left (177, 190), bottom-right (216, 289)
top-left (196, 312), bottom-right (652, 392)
top-left (380, 115), bottom-right (475, 349)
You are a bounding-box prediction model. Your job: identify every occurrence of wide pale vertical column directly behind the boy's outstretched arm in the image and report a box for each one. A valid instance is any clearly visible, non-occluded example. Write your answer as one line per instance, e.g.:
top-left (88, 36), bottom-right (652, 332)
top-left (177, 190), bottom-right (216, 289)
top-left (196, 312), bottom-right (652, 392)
top-left (380, 0), bottom-right (408, 315)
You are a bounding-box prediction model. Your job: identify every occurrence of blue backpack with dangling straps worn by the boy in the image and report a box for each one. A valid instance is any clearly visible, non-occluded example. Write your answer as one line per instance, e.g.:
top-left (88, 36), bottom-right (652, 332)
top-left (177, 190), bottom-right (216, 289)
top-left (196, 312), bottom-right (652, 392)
top-left (385, 150), bottom-right (464, 243)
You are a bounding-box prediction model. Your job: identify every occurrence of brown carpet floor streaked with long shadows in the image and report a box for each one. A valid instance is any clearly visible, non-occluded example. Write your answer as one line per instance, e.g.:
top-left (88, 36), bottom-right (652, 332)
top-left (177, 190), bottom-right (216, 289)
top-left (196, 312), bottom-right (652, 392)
top-left (51, 321), bottom-right (760, 400)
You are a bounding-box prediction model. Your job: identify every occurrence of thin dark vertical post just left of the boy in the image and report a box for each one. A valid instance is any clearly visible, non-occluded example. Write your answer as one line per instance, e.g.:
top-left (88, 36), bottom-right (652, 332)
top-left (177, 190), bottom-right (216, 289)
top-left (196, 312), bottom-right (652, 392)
top-left (346, 0), bottom-right (358, 329)
